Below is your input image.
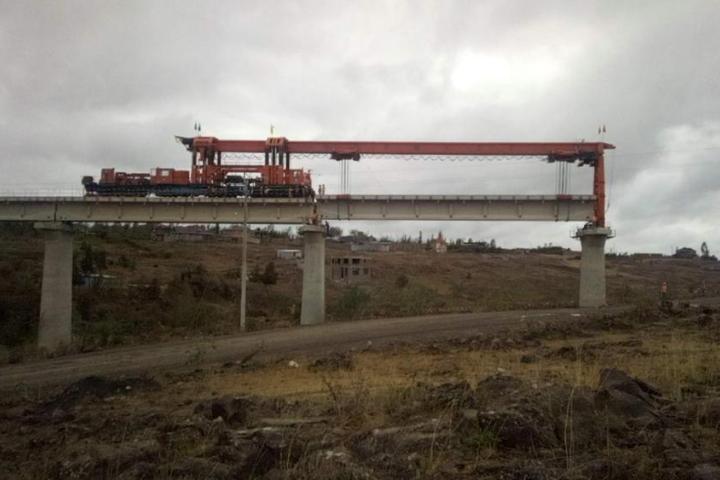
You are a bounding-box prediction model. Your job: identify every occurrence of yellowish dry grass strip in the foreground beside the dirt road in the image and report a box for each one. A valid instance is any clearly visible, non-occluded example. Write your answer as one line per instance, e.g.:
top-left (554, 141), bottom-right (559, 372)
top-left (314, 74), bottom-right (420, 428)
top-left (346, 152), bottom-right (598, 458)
top-left (183, 322), bottom-right (720, 408)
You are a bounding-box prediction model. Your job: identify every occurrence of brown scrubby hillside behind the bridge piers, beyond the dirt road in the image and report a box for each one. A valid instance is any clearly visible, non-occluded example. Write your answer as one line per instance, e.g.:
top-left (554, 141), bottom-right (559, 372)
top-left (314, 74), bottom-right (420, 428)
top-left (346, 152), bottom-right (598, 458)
top-left (0, 225), bottom-right (720, 356)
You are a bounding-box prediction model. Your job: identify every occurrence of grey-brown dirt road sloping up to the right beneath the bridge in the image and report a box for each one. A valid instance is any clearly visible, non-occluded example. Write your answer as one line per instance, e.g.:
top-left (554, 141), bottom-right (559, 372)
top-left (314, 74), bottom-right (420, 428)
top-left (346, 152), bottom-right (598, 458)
top-left (0, 307), bottom-right (623, 389)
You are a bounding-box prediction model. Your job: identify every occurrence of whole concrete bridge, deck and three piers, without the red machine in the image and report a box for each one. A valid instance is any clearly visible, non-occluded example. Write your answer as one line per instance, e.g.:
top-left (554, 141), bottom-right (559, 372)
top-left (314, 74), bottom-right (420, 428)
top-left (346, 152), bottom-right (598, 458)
top-left (0, 191), bottom-right (612, 351)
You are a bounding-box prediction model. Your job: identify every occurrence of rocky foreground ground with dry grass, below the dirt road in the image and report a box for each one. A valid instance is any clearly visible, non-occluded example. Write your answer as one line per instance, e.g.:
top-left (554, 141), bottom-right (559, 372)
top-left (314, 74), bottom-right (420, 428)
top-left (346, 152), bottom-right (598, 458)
top-left (0, 306), bottom-right (720, 480)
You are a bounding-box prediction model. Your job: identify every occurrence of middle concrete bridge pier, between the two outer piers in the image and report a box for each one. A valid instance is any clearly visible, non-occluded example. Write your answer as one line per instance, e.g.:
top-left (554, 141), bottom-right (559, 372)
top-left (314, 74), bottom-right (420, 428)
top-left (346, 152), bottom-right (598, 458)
top-left (300, 225), bottom-right (325, 325)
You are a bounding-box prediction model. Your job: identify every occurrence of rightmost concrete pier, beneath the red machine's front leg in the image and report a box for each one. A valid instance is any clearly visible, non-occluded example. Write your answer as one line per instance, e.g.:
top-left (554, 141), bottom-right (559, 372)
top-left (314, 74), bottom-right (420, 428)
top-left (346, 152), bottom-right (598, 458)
top-left (575, 227), bottom-right (613, 307)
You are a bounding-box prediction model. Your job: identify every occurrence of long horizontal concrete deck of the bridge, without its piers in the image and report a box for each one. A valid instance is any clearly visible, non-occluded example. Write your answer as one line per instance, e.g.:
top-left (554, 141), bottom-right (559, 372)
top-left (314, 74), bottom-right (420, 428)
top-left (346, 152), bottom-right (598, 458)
top-left (0, 195), bottom-right (596, 224)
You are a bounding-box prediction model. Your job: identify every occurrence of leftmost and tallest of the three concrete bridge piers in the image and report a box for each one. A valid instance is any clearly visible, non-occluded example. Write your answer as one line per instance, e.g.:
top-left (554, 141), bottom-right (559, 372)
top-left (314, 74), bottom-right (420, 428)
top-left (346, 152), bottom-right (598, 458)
top-left (35, 223), bottom-right (73, 352)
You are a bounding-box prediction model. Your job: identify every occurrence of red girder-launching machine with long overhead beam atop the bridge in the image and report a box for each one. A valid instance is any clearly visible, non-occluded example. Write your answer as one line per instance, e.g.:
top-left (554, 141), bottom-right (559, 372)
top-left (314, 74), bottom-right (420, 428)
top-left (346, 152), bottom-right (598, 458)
top-left (83, 137), bottom-right (615, 226)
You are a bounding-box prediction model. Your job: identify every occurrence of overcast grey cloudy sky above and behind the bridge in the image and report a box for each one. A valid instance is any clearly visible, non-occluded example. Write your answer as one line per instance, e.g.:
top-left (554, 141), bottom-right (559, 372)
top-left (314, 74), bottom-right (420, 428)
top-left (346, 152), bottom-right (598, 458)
top-left (0, 0), bottom-right (720, 253)
